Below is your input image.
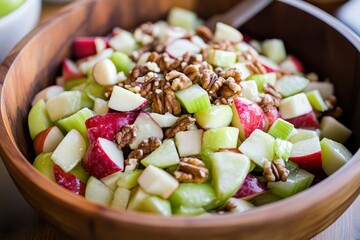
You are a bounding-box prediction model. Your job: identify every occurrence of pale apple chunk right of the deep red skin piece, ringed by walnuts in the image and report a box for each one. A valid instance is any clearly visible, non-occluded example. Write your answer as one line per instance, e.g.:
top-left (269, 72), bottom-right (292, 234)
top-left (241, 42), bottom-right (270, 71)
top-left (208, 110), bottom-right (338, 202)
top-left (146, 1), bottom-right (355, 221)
top-left (129, 112), bottom-right (164, 149)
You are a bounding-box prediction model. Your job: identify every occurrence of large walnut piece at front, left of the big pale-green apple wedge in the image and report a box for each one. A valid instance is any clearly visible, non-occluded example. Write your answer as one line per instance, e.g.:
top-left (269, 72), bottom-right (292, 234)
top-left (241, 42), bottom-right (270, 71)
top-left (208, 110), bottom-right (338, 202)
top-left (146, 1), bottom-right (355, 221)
top-left (174, 157), bottom-right (209, 183)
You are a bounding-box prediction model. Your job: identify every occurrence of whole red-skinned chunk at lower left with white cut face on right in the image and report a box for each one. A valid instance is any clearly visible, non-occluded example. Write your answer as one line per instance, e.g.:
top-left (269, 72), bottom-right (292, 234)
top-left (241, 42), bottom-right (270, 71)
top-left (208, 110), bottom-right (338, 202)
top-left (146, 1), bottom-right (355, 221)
top-left (81, 138), bottom-right (124, 179)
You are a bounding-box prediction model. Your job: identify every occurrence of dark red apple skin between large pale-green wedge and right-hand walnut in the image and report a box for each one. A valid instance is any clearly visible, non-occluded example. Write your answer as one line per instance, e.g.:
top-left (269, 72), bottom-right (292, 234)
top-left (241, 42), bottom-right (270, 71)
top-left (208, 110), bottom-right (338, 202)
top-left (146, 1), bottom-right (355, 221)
top-left (233, 173), bottom-right (266, 200)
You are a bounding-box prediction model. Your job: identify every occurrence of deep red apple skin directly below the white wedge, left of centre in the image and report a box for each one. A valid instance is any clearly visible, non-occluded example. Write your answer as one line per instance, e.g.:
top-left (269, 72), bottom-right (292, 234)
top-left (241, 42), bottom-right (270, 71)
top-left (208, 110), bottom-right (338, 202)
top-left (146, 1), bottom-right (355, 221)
top-left (85, 112), bottom-right (138, 142)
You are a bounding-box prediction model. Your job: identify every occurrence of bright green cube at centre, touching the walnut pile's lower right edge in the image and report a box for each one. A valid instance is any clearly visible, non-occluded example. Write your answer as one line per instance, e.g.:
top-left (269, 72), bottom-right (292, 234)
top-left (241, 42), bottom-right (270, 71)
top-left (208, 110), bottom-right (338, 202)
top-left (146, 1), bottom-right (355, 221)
top-left (175, 84), bottom-right (211, 113)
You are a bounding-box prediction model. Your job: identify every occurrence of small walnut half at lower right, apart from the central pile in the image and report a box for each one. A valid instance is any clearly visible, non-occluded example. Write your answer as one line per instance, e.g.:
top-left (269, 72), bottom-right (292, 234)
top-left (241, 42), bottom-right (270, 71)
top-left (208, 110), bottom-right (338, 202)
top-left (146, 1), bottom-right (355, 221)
top-left (263, 158), bottom-right (290, 182)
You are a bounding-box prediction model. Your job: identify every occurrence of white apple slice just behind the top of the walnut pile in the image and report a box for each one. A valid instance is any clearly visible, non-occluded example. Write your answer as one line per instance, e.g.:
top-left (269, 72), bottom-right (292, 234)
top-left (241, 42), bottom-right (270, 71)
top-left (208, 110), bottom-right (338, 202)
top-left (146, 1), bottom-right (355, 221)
top-left (166, 39), bottom-right (200, 58)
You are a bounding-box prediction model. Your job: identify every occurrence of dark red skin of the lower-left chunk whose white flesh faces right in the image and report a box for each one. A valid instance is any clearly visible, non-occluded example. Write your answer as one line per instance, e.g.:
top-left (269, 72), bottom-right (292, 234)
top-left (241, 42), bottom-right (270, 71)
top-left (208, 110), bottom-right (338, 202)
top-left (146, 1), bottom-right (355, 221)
top-left (81, 138), bottom-right (124, 179)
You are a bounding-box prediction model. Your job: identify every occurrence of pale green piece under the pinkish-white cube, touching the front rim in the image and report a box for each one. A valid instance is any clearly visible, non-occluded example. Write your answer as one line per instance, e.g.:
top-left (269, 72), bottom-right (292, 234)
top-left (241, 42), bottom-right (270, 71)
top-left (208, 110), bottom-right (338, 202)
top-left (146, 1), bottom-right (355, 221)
top-left (139, 196), bottom-right (172, 217)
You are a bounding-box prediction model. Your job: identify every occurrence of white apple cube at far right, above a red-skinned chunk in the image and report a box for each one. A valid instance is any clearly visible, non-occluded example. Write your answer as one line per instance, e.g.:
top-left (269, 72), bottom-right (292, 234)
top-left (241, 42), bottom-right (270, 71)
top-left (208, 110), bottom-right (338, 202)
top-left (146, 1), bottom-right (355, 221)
top-left (279, 93), bottom-right (312, 121)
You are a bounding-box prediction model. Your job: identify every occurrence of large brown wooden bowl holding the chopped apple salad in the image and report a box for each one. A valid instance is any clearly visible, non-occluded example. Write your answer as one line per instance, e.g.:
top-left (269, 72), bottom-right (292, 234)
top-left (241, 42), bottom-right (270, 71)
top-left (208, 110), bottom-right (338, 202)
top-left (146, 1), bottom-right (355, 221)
top-left (0, 0), bottom-right (360, 240)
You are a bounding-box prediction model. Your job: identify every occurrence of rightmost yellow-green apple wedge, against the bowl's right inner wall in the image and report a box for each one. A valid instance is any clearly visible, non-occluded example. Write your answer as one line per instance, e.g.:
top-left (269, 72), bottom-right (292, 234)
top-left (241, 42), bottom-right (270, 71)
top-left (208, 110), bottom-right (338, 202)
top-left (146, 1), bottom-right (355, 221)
top-left (320, 138), bottom-right (353, 176)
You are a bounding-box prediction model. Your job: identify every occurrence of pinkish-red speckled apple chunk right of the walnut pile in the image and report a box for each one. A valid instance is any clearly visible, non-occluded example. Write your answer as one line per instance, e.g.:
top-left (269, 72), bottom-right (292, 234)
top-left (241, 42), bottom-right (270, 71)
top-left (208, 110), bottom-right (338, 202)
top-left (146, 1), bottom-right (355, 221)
top-left (231, 97), bottom-right (265, 141)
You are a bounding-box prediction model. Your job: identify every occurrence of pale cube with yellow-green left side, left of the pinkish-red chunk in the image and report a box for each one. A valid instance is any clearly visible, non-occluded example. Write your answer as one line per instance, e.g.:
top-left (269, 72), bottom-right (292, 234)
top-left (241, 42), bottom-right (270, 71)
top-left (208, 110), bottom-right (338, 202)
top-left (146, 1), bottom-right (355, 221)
top-left (194, 105), bottom-right (233, 129)
